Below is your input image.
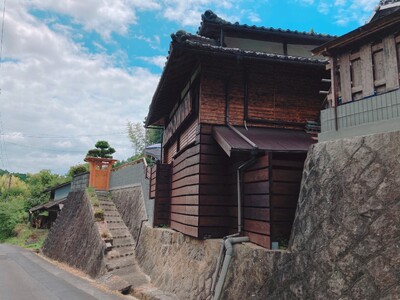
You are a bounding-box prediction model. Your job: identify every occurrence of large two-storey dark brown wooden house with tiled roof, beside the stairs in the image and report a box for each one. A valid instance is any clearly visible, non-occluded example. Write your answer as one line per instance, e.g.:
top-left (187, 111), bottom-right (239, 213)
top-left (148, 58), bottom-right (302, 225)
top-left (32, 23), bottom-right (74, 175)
top-left (146, 11), bottom-right (332, 248)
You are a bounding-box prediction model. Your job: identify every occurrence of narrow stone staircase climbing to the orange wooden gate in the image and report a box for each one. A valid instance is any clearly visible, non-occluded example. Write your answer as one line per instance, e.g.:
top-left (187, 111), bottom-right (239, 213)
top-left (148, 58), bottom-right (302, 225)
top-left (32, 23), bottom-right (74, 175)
top-left (96, 191), bottom-right (150, 292)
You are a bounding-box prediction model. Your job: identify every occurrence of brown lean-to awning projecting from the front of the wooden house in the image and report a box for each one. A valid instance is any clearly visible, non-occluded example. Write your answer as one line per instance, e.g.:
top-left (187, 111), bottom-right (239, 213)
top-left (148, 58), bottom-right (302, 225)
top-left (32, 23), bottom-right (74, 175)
top-left (213, 126), bottom-right (315, 156)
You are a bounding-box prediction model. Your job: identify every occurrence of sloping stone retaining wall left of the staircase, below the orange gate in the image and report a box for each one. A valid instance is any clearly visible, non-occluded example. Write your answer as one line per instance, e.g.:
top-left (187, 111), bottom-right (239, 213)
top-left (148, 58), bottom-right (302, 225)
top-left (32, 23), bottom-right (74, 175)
top-left (43, 191), bottom-right (105, 277)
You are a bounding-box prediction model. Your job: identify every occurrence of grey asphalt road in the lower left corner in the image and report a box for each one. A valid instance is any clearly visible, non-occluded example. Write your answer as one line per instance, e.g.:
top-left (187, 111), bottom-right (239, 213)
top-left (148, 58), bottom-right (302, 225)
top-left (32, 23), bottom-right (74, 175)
top-left (0, 244), bottom-right (128, 300)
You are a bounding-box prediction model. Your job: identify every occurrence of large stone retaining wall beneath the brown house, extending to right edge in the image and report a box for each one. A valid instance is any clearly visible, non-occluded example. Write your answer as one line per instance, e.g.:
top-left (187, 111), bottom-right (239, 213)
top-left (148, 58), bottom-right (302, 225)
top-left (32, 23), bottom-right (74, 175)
top-left (132, 132), bottom-right (400, 300)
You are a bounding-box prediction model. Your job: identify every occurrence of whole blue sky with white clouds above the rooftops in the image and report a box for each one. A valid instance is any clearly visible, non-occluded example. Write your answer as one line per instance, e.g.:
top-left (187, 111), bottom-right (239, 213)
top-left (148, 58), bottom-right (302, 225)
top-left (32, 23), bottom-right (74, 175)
top-left (0, 0), bottom-right (378, 174)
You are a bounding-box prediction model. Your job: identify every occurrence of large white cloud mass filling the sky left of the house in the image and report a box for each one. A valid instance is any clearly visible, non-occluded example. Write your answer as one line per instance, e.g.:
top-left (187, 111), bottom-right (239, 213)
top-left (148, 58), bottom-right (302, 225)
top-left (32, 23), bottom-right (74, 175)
top-left (0, 2), bottom-right (159, 173)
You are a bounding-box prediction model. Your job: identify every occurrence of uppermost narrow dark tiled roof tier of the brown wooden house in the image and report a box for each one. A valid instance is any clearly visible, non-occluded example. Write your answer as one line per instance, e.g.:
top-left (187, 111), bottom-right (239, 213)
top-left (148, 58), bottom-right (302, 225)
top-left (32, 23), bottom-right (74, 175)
top-left (198, 10), bottom-right (337, 38)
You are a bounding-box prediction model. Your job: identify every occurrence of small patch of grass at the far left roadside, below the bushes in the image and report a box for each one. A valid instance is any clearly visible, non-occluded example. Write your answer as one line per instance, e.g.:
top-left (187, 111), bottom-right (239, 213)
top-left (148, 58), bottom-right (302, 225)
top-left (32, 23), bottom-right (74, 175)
top-left (3, 224), bottom-right (49, 250)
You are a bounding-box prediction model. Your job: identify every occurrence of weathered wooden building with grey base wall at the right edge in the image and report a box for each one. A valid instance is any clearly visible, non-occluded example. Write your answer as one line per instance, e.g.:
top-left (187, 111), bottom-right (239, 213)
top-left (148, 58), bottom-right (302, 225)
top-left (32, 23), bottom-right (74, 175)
top-left (313, 1), bottom-right (400, 141)
